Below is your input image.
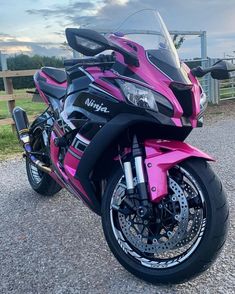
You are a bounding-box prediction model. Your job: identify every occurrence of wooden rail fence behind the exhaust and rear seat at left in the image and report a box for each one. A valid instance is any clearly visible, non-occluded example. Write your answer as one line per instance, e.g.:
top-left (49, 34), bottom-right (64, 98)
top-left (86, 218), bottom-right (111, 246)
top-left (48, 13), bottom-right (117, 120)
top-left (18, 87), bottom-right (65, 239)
top-left (0, 69), bottom-right (37, 131)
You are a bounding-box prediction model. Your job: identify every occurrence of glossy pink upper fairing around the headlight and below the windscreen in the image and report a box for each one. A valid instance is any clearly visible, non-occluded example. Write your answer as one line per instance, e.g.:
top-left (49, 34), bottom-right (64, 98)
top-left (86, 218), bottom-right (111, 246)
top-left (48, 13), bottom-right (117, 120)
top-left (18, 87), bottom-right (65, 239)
top-left (101, 35), bottom-right (201, 128)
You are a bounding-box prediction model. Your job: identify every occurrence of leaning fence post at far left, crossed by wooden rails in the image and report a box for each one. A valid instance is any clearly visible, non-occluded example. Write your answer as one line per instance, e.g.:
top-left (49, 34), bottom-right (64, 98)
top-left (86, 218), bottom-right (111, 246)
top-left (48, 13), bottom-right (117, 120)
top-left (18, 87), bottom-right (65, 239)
top-left (0, 52), bottom-right (15, 132)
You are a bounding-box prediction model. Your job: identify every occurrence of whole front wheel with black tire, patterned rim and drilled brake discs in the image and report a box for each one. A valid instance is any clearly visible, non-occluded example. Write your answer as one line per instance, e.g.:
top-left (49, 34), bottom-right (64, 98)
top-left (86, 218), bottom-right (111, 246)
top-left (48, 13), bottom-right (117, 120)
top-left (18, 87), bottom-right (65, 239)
top-left (102, 158), bottom-right (229, 284)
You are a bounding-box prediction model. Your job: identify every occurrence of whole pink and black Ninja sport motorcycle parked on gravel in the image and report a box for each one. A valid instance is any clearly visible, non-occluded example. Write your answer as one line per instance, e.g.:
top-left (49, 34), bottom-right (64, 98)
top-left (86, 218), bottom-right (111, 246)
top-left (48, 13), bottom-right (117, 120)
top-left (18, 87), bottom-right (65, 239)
top-left (13, 10), bottom-right (231, 283)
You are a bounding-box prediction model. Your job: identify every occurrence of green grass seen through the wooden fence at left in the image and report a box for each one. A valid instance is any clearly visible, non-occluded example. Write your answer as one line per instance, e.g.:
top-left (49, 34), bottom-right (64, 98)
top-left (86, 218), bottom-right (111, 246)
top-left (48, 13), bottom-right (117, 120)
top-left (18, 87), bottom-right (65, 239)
top-left (0, 89), bottom-right (46, 160)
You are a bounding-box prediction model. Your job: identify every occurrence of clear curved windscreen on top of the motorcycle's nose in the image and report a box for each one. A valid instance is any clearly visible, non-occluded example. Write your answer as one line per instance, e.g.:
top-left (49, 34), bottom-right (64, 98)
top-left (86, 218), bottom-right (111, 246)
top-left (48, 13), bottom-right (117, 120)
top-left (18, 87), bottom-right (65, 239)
top-left (115, 9), bottom-right (191, 84)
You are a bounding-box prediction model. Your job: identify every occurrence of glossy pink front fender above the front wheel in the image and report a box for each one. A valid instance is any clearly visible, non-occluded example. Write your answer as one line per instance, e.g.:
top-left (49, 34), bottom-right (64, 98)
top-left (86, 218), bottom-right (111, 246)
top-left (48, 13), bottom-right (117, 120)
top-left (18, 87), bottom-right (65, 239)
top-left (145, 140), bottom-right (214, 202)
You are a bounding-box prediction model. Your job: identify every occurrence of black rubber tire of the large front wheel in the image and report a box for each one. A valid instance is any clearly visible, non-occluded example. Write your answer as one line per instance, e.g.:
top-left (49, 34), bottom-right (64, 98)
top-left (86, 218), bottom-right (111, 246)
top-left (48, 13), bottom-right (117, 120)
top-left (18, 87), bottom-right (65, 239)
top-left (102, 158), bottom-right (229, 284)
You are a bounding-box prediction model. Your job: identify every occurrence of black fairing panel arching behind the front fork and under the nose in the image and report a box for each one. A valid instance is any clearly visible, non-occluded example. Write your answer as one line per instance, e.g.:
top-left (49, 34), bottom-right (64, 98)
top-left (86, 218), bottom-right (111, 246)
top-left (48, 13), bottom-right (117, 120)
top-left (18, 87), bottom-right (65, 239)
top-left (75, 113), bottom-right (191, 211)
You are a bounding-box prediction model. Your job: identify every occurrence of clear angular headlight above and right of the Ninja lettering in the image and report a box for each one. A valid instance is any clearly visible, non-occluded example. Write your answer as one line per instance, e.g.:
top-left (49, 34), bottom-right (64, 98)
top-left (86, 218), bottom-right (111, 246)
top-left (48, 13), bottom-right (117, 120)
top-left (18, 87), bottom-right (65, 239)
top-left (117, 80), bottom-right (173, 114)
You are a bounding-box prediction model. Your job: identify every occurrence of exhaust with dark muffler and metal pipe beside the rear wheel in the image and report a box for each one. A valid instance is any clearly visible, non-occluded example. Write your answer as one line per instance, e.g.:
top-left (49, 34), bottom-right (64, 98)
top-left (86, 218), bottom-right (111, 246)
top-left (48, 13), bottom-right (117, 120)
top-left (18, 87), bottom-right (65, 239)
top-left (12, 107), bottom-right (52, 174)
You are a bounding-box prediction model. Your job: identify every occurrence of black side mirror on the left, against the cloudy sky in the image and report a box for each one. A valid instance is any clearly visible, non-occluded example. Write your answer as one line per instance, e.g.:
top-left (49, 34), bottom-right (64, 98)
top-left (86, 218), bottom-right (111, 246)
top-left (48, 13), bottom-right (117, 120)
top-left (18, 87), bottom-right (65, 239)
top-left (65, 28), bottom-right (110, 56)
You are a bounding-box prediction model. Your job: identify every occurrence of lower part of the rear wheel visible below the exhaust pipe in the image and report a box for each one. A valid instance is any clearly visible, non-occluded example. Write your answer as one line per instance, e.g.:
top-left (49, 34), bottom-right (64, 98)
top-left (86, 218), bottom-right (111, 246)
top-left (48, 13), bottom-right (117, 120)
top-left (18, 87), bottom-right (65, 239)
top-left (26, 158), bottom-right (62, 196)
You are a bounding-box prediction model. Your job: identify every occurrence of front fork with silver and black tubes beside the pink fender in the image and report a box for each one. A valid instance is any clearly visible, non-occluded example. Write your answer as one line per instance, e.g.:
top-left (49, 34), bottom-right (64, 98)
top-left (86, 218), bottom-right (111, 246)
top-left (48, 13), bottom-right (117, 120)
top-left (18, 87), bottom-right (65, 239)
top-left (123, 136), bottom-right (150, 217)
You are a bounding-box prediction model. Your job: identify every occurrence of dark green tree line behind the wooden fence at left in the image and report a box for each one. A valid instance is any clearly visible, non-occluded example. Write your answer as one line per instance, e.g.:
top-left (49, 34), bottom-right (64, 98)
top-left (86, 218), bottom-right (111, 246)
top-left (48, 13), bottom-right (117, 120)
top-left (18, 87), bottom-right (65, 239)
top-left (0, 54), bottom-right (64, 90)
